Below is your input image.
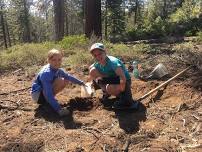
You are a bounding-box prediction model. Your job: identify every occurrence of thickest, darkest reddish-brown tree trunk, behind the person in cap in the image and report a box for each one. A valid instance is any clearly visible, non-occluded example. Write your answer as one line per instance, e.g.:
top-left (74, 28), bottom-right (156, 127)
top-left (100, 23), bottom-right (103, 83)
top-left (85, 0), bottom-right (102, 38)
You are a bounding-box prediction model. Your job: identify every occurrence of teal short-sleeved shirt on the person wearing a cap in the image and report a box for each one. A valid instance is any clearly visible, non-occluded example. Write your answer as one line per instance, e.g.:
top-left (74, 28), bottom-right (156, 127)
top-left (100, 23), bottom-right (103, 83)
top-left (94, 56), bottom-right (130, 80)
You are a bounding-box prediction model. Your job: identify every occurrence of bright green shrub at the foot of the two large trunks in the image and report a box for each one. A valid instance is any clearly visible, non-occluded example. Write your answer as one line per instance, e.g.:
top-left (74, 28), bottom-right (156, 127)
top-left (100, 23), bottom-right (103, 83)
top-left (59, 35), bottom-right (88, 49)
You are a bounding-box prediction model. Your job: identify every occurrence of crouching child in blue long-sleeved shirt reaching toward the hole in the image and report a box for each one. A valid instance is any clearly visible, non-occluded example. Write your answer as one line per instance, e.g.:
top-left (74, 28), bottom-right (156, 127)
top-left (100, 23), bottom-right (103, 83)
top-left (31, 49), bottom-right (85, 116)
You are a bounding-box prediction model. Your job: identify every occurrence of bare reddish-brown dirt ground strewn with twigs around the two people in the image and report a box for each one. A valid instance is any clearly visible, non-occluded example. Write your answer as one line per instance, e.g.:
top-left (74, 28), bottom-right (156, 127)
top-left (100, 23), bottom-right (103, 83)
top-left (0, 50), bottom-right (202, 152)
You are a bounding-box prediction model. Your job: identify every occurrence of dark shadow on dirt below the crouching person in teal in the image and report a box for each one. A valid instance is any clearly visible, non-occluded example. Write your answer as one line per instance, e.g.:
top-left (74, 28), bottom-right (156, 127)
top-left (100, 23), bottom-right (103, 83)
top-left (115, 103), bottom-right (146, 133)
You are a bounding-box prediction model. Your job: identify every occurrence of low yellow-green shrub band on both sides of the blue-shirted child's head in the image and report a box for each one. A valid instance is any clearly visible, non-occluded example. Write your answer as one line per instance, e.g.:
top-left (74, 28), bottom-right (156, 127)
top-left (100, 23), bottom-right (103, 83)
top-left (0, 41), bottom-right (92, 71)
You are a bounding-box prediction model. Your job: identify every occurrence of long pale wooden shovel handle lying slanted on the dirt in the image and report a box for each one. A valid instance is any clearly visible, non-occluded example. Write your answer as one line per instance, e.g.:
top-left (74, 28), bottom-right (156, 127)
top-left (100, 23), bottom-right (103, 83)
top-left (137, 66), bottom-right (192, 101)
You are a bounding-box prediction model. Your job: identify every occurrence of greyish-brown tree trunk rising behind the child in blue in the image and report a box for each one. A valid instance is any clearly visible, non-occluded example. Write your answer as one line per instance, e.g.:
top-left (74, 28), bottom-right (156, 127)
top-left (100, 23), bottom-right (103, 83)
top-left (53, 0), bottom-right (64, 41)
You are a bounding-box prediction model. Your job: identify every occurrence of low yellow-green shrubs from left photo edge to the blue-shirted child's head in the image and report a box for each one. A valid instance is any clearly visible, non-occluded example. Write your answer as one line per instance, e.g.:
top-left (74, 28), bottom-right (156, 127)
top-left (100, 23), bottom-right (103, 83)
top-left (0, 44), bottom-right (48, 70)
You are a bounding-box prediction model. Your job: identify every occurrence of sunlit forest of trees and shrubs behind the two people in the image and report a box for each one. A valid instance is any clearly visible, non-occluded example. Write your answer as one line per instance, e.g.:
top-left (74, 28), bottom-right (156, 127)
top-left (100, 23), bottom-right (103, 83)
top-left (0, 0), bottom-right (202, 71)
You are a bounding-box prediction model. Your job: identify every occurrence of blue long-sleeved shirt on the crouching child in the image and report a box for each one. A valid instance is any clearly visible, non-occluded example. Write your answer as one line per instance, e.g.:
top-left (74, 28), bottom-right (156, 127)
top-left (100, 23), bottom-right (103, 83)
top-left (31, 64), bottom-right (83, 112)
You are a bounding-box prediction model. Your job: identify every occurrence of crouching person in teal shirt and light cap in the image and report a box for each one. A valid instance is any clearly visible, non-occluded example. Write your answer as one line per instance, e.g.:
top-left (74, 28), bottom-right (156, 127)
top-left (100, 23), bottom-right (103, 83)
top-left (89, 43), bottom-right (137, 109)
